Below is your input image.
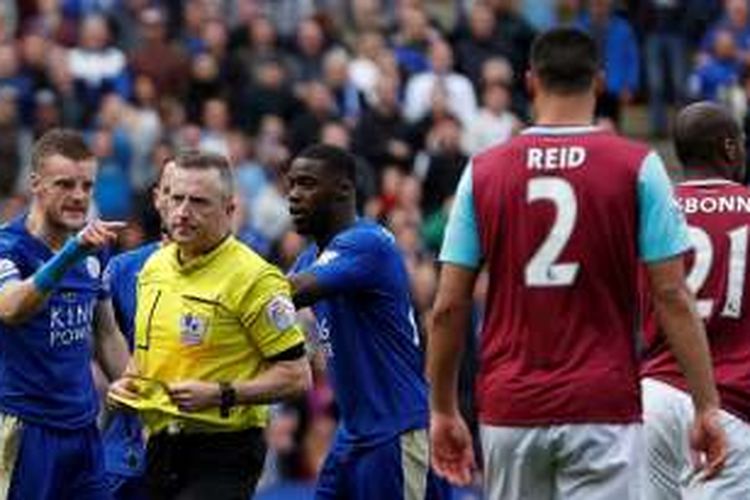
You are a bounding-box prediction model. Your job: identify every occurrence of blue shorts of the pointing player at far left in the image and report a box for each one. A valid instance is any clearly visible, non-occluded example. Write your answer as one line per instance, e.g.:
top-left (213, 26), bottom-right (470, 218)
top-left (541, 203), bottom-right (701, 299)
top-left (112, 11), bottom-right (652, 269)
top-left (0, 415), bottom-right (112, 500)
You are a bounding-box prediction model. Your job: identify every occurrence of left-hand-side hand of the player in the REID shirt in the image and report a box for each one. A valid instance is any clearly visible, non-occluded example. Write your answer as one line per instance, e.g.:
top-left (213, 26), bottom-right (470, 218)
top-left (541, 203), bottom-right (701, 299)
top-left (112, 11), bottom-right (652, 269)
top-left (430, 412), bottom-right (476, 486)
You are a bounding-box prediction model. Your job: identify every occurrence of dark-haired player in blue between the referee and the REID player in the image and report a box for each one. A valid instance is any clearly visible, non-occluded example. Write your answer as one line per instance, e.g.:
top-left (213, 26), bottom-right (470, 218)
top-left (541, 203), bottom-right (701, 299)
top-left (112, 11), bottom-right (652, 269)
top-left (288, 145), bottom-right (445, 500)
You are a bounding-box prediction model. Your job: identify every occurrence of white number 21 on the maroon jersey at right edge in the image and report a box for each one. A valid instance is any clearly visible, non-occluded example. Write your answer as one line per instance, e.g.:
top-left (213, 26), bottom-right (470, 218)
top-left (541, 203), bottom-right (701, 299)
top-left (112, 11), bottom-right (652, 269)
top-left (687, 226), bottom-right (748, 318)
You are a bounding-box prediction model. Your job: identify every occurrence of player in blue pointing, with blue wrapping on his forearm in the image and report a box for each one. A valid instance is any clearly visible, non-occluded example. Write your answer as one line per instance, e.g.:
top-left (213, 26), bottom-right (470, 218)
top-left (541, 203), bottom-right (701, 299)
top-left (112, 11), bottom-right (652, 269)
top-left (0, 130), bottom-right (128, 500)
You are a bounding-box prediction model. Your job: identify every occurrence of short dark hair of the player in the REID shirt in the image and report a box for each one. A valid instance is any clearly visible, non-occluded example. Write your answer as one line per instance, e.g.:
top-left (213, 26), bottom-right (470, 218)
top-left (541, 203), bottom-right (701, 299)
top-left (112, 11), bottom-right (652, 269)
top-left (531, 28), bottom-right (599, 95)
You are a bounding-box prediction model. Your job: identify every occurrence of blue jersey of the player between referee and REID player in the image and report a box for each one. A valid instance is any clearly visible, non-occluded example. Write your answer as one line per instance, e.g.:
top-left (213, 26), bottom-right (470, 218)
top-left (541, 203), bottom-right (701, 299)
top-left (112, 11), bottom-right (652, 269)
top-left (292, 220), bottom-right (428, 446)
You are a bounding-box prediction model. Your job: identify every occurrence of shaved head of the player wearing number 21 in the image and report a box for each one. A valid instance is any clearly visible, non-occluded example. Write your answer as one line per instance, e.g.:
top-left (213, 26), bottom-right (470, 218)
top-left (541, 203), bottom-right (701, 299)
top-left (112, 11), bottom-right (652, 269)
top-left (674, 101), bottom-right (745, 181)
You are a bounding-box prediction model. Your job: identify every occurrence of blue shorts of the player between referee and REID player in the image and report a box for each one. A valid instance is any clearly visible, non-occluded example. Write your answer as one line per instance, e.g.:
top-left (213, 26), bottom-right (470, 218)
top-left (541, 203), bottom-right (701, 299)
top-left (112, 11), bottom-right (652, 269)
top-left (315, 429), bottom-right (451, 500)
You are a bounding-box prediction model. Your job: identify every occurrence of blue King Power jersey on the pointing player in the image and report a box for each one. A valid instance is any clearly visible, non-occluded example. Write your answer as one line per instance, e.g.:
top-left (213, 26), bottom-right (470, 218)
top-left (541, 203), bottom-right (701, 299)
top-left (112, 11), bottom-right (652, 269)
top-left (0, 217), bottom-right (106, 429)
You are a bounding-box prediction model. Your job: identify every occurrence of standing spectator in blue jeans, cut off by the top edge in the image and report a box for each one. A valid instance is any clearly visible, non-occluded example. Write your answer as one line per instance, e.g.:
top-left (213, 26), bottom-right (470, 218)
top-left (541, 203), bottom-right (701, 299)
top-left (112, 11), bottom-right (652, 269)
top-left (639, 0), bottom-right (689, 137)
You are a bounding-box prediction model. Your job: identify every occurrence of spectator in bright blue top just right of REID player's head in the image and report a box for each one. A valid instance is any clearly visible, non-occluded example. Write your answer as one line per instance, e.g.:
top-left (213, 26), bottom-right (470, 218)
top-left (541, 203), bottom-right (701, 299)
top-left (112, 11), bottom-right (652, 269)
top-left (578, 0), bottom-right (640, 126)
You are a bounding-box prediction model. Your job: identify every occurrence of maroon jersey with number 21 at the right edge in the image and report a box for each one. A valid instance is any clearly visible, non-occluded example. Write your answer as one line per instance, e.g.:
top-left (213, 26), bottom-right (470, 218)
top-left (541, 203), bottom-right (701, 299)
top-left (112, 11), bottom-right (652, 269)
top-left (642, 179), bottom-right (750, 422)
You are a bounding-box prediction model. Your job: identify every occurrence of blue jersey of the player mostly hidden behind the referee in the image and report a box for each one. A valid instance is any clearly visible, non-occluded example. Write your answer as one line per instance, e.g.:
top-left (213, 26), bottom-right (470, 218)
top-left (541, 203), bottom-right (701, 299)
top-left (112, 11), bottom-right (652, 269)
top-left (103, 242), bottom-right (159, 477)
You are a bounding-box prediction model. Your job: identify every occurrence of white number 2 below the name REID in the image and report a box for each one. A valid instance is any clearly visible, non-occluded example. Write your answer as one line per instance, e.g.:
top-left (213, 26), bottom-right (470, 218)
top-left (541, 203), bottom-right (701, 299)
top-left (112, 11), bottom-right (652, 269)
top-left (525, 177), bottom-right (580, 287)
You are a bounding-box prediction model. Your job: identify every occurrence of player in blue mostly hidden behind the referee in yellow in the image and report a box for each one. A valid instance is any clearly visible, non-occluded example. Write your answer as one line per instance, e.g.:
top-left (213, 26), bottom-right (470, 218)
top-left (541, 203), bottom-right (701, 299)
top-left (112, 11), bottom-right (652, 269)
top-left (98, 160), bottom-right (174, 500)
